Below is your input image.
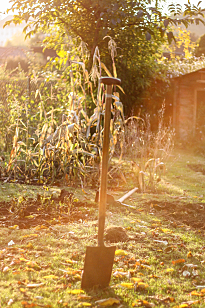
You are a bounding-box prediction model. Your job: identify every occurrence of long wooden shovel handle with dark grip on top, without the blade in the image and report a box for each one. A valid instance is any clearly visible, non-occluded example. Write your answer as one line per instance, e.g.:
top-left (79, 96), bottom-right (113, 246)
top-left (98, 77), bottom-right (120, 246)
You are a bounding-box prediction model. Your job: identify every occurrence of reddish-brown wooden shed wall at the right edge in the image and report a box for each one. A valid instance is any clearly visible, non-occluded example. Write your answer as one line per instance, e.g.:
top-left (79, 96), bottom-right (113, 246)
top-left (171, 68), bottom-right (205, 139)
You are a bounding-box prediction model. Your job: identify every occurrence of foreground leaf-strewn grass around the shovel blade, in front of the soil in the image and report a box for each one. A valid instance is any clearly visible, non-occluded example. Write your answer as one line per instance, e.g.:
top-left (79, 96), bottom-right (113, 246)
top-left (0, 208), bottom-right (205, 307)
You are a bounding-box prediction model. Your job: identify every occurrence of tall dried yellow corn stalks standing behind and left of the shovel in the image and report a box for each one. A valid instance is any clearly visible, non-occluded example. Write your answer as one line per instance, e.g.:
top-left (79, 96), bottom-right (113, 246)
top-left (0, 46), bottom-right (124, 187)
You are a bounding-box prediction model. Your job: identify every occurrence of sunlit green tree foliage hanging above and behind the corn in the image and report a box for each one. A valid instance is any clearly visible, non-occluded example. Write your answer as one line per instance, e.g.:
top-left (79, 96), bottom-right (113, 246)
top-left (6, 0), bottom-right (205, 113)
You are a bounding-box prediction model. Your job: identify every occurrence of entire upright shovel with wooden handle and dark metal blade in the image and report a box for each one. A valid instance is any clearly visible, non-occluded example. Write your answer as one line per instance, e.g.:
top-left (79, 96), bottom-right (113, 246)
top-left (81, 77), bottom-right (121, 289)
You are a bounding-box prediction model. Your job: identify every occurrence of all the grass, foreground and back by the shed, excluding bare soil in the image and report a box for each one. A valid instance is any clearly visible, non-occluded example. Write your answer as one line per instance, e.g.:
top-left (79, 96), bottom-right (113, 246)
top-left (0, 151), bottom-right (205, 308)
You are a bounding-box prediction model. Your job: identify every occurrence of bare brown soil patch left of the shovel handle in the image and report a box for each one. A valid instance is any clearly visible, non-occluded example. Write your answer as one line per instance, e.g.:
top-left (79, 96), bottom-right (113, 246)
top-left (0, 199), bottom-right (97, 229)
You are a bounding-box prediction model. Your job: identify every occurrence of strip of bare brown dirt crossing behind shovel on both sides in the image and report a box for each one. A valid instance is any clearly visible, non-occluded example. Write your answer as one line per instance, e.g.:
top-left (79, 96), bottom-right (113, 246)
top-left (0, 190), bottom-right (205, 229)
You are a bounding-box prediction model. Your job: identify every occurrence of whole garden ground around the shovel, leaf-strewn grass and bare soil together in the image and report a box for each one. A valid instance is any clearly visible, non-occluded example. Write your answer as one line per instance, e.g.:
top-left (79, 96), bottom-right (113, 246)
top-left (0, 149), bottom-right (205, 308)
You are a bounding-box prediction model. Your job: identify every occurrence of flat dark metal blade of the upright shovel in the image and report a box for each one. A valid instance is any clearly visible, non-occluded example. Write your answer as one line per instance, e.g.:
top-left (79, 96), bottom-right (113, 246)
top-left (81, 246), bottom-right (116, 289)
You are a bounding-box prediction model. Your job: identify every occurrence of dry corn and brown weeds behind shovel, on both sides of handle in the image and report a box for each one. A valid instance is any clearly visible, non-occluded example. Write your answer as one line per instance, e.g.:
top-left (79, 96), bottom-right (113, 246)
top-left (0, 40), bottom-right (173, 191)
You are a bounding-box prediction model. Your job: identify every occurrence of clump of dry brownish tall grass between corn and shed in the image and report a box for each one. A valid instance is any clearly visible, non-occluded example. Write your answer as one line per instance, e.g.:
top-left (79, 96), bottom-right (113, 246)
top-left (126, 105), bottom-right (174, 192)
